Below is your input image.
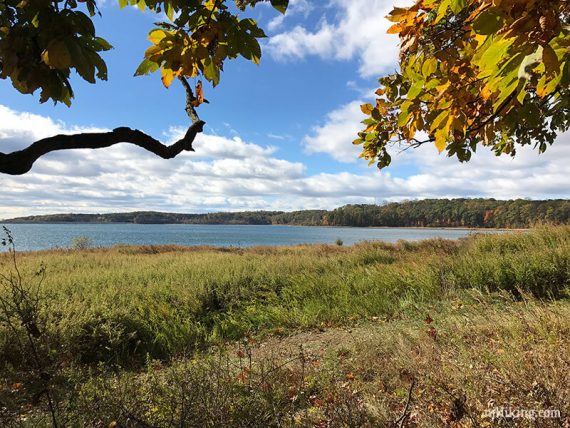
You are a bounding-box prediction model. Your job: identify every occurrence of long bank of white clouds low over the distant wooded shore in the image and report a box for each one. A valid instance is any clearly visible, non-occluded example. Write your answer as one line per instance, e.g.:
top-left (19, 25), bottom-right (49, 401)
top-left (0, 103), bottom-right (570, 218)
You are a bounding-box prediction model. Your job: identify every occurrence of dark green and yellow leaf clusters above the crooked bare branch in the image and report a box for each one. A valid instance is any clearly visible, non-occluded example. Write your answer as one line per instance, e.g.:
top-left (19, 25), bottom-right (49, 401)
top-left (0, 0), bottom-right (289, 106)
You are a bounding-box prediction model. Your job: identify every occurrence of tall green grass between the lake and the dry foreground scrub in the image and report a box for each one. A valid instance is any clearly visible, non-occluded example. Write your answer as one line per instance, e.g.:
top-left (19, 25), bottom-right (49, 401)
top-left (0, 227), bottom-right (570, 363)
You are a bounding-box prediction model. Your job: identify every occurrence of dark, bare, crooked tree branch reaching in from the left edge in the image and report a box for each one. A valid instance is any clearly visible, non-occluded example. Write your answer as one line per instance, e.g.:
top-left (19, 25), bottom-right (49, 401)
top-left (0, 78), bottom-right (206, 175)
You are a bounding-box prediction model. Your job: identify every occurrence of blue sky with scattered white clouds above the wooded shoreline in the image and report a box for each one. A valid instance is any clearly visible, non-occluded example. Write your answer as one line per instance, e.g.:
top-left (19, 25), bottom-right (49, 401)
top-left (0, 0), bottom-right (570, 218)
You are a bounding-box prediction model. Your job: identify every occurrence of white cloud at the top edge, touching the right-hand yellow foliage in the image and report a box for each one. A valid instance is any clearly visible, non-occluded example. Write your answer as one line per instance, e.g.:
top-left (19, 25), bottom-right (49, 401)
top-left (267, 0), bottom-right (410, 77)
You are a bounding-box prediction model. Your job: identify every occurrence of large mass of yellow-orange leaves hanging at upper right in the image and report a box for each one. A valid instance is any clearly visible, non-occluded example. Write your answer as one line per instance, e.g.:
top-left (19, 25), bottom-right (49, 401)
top-left (354, 0), bottom-right (570, 168)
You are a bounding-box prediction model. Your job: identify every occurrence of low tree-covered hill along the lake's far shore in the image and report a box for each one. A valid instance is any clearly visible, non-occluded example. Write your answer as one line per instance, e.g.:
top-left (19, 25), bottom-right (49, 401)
top-left (3, 199), bottom-right (570, 228)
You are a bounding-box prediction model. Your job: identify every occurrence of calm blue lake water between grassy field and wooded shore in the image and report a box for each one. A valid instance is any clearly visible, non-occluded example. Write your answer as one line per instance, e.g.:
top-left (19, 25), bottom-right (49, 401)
top-left (0, 223), bottom-right (496, 251)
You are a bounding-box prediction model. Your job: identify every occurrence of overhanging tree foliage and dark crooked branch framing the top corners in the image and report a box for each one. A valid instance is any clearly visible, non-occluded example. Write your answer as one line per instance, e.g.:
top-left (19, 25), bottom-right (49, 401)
top-left (0, 0), bottom-right (570, 174)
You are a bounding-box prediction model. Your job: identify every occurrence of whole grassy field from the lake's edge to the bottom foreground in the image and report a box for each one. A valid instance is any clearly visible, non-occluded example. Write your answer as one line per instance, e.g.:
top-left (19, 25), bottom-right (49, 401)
top-left (0, 227), bottom-right (570, 427)
